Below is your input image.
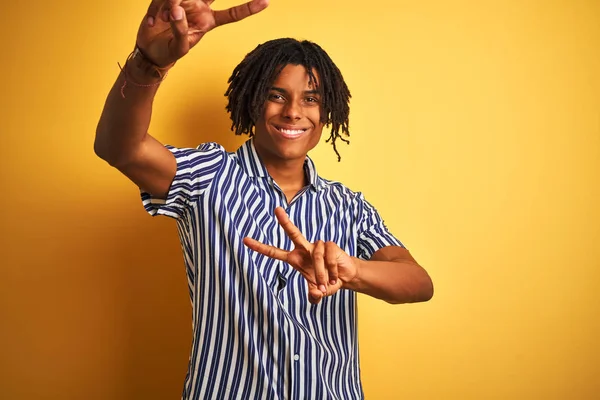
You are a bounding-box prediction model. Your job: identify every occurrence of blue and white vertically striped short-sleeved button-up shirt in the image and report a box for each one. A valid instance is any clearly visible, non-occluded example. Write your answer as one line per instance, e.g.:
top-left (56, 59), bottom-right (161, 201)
top-left (142, 139), bottom-right (402, 400)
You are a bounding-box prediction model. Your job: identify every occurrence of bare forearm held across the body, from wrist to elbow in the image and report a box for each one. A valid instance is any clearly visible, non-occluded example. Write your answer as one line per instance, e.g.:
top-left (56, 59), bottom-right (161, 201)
top-left (344, 257), bottom-right (433, 304)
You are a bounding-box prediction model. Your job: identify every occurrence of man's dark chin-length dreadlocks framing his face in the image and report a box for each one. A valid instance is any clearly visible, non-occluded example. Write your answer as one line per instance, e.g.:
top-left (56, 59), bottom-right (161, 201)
top-left (225, 38), bottom-right (350, 161)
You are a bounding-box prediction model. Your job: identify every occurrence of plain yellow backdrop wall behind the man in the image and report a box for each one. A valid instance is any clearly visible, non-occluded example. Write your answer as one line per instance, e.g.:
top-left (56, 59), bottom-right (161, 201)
top-left (0, 0), bottom-right (600, 400)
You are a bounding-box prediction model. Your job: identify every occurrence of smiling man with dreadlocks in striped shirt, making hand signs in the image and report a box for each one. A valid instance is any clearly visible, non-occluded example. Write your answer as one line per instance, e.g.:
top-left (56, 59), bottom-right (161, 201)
top-left (95, 0), bottom-right (433, 399)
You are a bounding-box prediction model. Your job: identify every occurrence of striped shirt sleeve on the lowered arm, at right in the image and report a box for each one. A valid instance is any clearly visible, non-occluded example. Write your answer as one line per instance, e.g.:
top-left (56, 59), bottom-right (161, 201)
top-left (358, 193), bottom-right (404, 260)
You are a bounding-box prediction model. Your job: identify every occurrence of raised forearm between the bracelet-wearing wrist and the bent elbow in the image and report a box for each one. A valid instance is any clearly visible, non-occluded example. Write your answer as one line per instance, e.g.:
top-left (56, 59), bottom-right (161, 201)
top-left (94, 54), bottom-right (168, 166)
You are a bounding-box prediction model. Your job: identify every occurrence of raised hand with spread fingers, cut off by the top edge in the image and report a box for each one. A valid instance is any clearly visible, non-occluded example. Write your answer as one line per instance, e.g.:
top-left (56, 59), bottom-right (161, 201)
top-left (137, 0), bottom-right (269, 67)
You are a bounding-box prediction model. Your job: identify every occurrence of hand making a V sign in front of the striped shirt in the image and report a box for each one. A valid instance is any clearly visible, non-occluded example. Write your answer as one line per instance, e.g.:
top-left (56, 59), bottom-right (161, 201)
top-left (244, 207), bottom-right (357, 304)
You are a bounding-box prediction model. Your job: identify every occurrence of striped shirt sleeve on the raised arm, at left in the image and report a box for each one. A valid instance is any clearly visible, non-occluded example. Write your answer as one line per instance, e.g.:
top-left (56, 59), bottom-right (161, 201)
top-left (141, 143), bottom-right (225, 219)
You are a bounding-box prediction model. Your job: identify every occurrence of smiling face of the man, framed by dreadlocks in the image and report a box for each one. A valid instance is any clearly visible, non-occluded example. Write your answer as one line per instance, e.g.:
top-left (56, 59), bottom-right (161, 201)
top-left (254, 64), bottom-right (324, 166)
